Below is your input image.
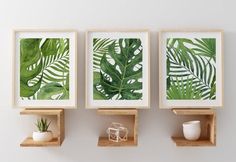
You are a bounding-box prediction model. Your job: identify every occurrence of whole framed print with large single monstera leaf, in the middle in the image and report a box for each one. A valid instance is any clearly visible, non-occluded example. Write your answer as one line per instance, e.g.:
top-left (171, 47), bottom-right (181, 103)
top-left (86, 30), bottom-right (150, 108)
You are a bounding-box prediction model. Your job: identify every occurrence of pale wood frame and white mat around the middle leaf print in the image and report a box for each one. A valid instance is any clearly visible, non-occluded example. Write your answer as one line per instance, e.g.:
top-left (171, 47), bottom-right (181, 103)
top-left (86, 32), bottom-right (150, 108)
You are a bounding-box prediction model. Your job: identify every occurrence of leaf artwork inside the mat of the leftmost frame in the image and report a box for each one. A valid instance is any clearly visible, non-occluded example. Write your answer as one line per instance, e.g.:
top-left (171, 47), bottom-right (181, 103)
top-left (20, 38), bottom-right (69, 100)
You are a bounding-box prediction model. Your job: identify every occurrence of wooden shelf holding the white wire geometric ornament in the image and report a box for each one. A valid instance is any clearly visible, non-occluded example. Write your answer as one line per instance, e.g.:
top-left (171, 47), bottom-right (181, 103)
top-left (97, 109), bottom-right (138, 147)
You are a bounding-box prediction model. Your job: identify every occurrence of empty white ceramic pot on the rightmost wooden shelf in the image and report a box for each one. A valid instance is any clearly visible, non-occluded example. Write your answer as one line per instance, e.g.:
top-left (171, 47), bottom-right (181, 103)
top-left (183, 120), bottom-right (201, 141)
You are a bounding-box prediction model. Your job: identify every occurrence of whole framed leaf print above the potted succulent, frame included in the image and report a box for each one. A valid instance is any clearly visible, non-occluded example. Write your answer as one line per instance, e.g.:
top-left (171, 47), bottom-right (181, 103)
top-left (13, 30), bottom-right (77, 108)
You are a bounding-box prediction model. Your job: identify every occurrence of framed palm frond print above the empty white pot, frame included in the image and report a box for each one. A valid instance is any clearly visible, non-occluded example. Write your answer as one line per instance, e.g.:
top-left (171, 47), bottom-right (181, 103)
top-left (159, 30), bottom-right (223, 108)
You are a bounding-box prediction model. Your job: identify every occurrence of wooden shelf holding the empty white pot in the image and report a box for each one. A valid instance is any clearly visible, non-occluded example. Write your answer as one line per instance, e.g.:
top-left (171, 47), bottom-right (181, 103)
top-left (171, 108), bottom-right (216, 146)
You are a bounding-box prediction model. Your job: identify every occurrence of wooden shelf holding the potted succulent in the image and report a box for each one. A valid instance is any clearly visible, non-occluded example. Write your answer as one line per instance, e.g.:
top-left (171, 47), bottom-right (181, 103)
top-left (20, 109), bottom-right (65, 147)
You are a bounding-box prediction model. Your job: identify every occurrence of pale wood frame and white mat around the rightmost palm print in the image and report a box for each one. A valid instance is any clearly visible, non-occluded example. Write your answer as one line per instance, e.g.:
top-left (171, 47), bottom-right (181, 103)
top-left (159, 32), bottom-right (223, 108)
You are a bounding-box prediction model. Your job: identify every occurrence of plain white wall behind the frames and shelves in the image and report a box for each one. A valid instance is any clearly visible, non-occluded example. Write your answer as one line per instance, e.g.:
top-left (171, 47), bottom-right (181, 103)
top-left (0, 0), bottom-right (236, 162)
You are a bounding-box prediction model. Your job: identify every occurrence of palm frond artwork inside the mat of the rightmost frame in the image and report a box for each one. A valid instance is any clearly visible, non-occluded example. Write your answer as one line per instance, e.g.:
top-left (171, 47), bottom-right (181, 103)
top-left (166, 38), bottom-right (216, 100)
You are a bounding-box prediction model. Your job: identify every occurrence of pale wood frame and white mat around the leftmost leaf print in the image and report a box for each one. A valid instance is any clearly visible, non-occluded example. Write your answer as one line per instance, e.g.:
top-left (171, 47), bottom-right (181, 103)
top-left (14, 31), bottom-right (77, 108)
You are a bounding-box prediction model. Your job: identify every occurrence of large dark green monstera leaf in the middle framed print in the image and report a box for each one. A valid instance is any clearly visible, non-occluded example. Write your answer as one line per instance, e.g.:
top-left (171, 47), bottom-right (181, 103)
top-left (93, 38), bottom-right (143, 100)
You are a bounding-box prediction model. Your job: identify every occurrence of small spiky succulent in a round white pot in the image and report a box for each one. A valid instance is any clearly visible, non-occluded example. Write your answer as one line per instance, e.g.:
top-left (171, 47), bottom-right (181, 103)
top-left (33, 118), bottom-right (53, 142)
